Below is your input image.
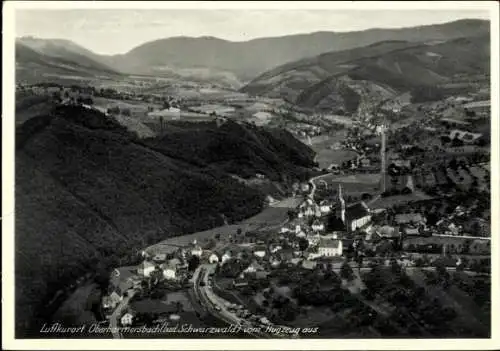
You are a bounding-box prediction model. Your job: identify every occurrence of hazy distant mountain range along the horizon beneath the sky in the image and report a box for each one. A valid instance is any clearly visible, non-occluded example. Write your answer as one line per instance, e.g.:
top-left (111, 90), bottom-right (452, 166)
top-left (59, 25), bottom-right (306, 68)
top-left (17, 20), bottom-right (490, 85)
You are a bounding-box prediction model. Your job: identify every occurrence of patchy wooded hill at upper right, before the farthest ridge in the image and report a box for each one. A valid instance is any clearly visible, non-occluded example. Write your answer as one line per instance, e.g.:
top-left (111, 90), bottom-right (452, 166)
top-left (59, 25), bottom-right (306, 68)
top-left (241, 35), bottom-right (490, 113)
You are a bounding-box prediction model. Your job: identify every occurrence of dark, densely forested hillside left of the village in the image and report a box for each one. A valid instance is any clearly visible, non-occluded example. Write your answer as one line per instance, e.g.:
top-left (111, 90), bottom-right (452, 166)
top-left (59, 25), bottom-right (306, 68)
top-left (15, 106), bottom-right (314, 337)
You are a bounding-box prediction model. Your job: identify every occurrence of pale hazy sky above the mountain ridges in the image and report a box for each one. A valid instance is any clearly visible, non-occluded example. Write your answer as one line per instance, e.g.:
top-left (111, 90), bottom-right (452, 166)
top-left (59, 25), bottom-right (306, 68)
top-left (15, 9), bottom-right (489, 54)
